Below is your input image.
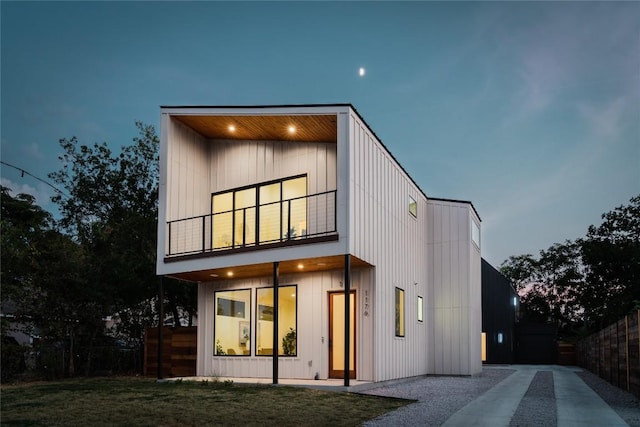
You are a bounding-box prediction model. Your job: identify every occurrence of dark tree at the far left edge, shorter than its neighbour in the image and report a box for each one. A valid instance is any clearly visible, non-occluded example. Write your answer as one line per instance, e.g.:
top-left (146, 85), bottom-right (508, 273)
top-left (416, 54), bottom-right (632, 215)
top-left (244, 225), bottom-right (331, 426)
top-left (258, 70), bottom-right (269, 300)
top-left (1, 187), bottom-right (104, 375)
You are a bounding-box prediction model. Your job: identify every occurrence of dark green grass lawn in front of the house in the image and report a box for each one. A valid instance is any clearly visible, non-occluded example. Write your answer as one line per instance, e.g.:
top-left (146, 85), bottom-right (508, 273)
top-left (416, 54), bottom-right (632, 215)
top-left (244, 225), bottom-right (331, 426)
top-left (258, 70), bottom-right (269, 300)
top-left (0, 377), bottom-right (411, 426)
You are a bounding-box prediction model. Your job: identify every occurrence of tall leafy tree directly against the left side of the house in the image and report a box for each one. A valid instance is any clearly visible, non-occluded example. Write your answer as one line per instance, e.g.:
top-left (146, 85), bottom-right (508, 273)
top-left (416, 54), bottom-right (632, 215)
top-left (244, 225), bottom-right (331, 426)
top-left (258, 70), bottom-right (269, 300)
top-left (49, 122), bottom-right (196, 345)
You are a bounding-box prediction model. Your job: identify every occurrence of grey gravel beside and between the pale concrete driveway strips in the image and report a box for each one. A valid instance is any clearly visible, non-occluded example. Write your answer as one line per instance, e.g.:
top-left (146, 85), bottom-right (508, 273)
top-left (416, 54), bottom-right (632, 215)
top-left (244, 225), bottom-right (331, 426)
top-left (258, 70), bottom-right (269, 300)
top-left (363, 367), bottom-right (640, 427)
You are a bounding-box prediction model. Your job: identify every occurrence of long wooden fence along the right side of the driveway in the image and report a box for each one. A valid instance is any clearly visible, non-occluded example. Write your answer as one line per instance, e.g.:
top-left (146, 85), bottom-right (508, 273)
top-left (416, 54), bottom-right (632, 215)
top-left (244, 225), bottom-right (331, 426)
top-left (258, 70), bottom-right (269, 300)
top-left (576, 310), bottom-right (640, 397)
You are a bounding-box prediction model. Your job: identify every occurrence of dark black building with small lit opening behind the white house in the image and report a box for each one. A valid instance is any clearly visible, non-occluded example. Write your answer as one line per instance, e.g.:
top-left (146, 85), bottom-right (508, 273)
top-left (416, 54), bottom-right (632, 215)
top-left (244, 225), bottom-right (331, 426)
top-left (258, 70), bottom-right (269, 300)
top-left (482, 258), bottom-right (520, 364)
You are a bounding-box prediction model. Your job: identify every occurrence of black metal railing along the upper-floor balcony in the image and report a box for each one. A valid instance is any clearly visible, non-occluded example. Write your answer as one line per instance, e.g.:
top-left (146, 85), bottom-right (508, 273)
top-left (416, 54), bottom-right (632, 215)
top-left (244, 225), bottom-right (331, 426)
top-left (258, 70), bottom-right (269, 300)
top-left (166, 190), bottom-right (337, 257)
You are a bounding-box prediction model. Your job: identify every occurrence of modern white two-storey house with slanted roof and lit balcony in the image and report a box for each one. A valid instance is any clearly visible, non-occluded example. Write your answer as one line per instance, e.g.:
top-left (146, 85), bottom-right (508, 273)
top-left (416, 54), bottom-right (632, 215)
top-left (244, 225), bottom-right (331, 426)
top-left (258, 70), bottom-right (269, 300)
top-left (157, 104), bottom-right (482, 385)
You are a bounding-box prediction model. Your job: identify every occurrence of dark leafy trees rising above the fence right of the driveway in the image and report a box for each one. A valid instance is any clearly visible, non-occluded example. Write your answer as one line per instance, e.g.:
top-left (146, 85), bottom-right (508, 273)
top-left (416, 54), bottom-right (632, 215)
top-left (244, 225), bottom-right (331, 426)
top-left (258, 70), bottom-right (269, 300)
top-left (501, 196), bottom-right (640, 333)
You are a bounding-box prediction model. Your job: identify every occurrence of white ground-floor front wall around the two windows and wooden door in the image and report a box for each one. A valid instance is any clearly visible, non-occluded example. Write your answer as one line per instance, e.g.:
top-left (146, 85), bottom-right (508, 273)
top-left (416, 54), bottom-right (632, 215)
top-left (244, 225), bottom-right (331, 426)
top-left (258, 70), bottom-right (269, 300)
top-left (196, 269), bottom-right (374, 381)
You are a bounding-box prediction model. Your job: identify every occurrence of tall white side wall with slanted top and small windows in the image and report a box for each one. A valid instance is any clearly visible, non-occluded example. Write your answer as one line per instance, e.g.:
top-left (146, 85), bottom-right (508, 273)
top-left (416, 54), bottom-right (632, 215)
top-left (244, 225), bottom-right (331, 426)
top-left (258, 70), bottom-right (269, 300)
top-left (349, 112), bottom-right (428, 381)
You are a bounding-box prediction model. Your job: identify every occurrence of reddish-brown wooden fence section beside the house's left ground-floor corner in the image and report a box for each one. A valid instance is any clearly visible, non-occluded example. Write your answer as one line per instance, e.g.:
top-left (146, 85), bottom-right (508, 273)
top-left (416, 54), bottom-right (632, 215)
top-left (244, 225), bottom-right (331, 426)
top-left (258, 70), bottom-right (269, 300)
top-left (144, 326), bottom-right (198, 377)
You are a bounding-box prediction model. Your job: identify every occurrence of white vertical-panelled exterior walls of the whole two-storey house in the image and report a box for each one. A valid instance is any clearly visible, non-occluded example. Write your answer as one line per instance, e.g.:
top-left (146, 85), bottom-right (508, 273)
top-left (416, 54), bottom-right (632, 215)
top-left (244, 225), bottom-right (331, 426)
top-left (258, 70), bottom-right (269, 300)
top-left (157, 106), bottom-right (482, 381)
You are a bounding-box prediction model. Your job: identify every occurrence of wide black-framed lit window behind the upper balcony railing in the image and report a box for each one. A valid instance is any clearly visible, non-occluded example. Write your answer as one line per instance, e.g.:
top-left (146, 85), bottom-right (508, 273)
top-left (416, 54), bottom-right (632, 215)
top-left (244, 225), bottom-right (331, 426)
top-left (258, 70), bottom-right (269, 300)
top-left (211, 176), bottom-right (307, 249)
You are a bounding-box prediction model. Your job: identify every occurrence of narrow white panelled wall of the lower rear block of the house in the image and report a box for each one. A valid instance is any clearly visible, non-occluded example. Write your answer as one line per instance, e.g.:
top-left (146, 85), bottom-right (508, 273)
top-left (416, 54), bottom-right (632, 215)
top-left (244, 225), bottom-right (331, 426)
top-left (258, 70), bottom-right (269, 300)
top-left (426, 200), bottom-right (482, 375)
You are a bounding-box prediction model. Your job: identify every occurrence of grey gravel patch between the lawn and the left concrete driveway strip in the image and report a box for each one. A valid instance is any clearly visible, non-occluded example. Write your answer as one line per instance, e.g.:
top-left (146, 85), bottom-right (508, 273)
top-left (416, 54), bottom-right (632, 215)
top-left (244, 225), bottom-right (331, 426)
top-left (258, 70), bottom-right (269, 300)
top-left (363, 369), bottom-right (514, 426)
